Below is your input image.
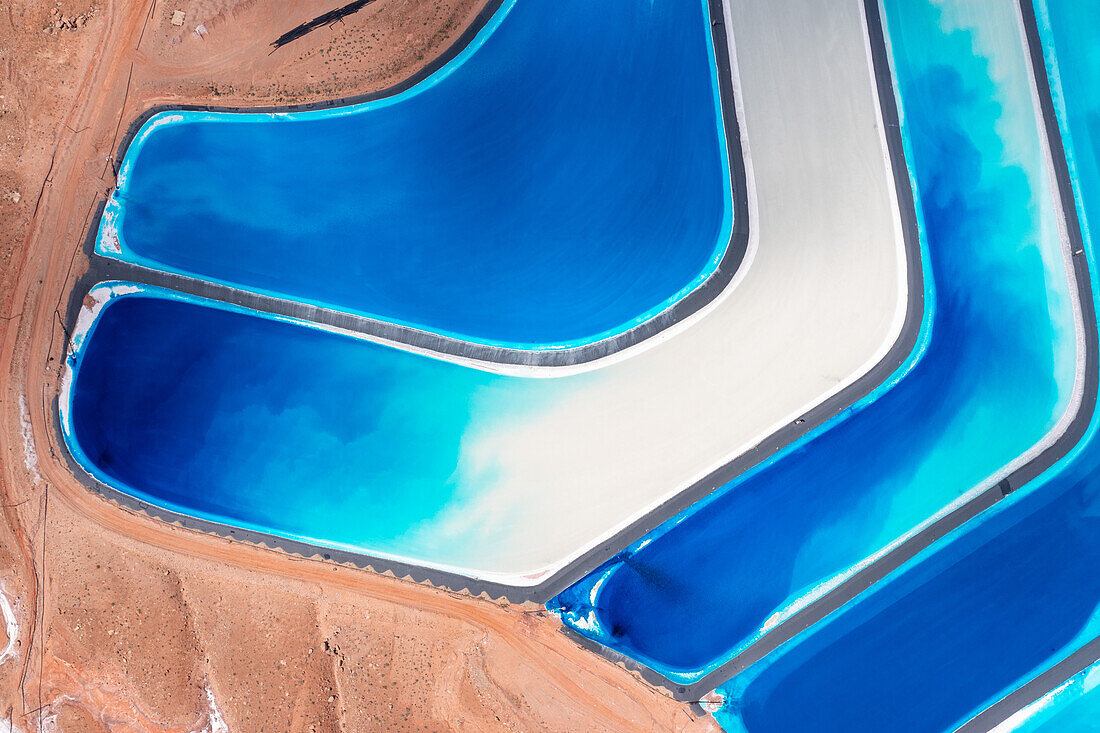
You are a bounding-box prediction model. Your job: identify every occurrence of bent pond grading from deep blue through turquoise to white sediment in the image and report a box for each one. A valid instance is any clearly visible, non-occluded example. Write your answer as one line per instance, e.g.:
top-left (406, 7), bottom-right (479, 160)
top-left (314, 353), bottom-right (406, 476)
top-left (61, 2), bottom-right (906, 599)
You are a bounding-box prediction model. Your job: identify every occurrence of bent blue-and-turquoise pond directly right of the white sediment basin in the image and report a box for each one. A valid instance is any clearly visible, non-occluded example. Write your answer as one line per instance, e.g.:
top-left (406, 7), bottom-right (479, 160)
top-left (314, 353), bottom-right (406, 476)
top-left (548, 0), bottom-right (1076, 686)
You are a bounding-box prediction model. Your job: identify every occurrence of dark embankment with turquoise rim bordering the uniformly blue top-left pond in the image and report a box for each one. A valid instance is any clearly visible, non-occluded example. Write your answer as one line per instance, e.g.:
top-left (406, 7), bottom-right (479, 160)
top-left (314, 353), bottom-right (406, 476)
top-left (89, 0), bottom-right (752, 369)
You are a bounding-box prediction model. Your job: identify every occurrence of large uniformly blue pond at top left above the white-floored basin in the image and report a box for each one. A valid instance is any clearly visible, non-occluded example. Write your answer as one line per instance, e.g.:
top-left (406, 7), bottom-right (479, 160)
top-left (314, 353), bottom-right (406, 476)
top-left (97, 0), bottom-right (733, 348)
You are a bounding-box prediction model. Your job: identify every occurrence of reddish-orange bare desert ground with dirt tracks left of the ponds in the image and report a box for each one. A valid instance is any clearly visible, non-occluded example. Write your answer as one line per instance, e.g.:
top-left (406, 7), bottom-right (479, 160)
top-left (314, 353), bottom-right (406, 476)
top-left (0, 0), bottom-right (715, 733)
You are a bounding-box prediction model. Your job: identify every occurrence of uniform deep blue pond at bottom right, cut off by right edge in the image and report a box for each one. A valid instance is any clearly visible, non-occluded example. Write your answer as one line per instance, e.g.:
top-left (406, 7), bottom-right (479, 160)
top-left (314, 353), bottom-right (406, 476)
top-left (719, 457), bottom-right (1100, 733)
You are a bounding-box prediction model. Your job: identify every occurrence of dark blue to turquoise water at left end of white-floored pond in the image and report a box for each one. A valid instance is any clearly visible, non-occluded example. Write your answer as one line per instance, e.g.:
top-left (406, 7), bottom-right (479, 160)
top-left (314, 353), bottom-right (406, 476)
top-left (64, 285), bottom-right (509, 555)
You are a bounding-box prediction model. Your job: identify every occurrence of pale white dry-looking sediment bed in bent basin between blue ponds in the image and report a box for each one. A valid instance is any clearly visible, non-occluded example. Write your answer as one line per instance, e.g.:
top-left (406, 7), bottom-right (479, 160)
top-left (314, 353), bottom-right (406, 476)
top-left (61, 0), bottom-right (909, 587)
